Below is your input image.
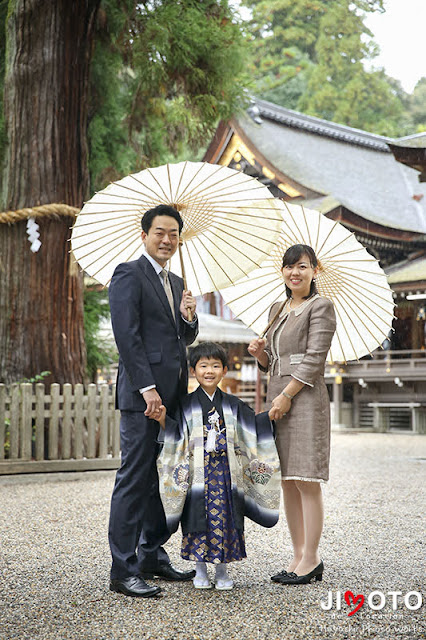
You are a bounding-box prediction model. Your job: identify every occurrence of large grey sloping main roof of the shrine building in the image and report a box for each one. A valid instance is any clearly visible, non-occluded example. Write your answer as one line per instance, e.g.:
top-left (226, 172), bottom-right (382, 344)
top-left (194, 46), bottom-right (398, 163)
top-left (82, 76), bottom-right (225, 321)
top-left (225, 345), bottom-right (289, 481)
top-left (236, 100), bottom-right (426, 234)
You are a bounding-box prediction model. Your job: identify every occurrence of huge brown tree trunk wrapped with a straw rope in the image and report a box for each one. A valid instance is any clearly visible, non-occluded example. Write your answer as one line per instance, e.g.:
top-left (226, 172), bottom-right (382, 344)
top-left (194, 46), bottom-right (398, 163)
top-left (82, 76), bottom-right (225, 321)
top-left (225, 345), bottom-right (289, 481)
top-left (0, 0), bottom-right (100, 383)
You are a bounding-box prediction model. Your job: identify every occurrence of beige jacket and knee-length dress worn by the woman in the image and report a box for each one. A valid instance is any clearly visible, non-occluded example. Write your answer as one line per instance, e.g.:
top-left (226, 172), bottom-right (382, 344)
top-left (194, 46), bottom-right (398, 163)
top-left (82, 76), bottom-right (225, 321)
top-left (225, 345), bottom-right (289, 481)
top-left (266, 295), bottom-right (336, 482)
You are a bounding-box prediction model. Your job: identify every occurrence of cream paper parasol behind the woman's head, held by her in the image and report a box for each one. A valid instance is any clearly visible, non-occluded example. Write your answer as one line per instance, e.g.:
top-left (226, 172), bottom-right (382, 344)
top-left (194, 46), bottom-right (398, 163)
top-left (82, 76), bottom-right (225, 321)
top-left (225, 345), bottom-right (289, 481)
top-left (221, 203), bottom-right (394, 362)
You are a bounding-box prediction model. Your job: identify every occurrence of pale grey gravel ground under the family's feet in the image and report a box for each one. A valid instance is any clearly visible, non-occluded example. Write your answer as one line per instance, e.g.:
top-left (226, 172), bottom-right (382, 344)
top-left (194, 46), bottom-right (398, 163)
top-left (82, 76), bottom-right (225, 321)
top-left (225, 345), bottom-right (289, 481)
top-left (0, 432), bottom-right (426, 640)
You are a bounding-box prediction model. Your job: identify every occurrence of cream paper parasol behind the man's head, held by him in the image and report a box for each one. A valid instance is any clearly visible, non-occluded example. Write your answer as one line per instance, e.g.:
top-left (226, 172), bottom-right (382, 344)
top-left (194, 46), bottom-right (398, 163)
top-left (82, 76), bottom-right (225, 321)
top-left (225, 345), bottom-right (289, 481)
top-left (71, 162), bottom-right (281, 295)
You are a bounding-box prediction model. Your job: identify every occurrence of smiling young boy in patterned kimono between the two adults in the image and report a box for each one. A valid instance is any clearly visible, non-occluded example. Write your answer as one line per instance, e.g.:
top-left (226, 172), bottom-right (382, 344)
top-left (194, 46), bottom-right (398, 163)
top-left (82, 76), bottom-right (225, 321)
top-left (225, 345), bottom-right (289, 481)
top-left (157, 342), bottom-right (281, 590)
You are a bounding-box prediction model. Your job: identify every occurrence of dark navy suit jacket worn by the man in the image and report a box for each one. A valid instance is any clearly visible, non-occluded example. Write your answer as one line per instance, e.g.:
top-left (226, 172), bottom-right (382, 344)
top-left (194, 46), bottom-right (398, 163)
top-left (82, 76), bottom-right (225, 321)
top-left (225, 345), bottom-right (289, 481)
top-left (109, 256), bottom-right (198, 411)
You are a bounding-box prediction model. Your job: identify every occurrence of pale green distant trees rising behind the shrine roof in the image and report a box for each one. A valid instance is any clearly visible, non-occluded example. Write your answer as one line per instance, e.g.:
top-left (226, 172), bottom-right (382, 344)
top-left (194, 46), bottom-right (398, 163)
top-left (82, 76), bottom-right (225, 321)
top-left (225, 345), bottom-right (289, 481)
top-left (244, 0), bottom-right (409, 137)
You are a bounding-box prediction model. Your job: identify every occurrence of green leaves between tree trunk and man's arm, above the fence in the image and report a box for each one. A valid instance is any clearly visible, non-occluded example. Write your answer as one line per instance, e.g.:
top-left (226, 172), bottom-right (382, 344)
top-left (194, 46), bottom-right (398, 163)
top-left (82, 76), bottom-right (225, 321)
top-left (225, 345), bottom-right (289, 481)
top-left (84, 289), bottom-right (117, 382)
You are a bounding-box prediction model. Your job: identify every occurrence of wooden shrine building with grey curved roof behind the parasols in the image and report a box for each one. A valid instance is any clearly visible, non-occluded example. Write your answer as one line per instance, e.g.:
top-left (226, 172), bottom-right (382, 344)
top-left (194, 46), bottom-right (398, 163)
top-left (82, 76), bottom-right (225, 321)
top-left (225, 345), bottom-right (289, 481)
top-left (203, 99), bottom-right (426, 433)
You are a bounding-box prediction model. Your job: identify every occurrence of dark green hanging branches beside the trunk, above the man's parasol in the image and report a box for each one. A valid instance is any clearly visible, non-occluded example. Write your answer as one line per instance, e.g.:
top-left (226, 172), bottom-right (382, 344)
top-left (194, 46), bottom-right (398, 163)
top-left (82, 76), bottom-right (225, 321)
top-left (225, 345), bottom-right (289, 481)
top-left (89, 0), bottom-right (247, 189)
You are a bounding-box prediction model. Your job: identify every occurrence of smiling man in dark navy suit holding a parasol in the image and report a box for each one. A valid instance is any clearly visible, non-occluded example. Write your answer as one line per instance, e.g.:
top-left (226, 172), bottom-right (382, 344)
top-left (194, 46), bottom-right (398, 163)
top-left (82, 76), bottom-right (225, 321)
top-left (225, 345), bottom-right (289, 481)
top-left (109, 205), bottom-right (198, 597)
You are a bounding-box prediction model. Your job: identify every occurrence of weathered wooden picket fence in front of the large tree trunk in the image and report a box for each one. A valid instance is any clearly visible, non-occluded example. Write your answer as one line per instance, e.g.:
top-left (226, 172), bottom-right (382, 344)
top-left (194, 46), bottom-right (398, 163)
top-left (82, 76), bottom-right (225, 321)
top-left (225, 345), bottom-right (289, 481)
top-left (0, 383), bottom-right (120, 475)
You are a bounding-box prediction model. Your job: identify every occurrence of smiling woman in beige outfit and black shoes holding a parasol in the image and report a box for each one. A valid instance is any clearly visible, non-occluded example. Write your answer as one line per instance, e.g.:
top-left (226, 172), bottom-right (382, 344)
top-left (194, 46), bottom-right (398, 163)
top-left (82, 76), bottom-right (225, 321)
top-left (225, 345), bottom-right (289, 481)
top-left (248, 244), bottom-right (336, 584)
